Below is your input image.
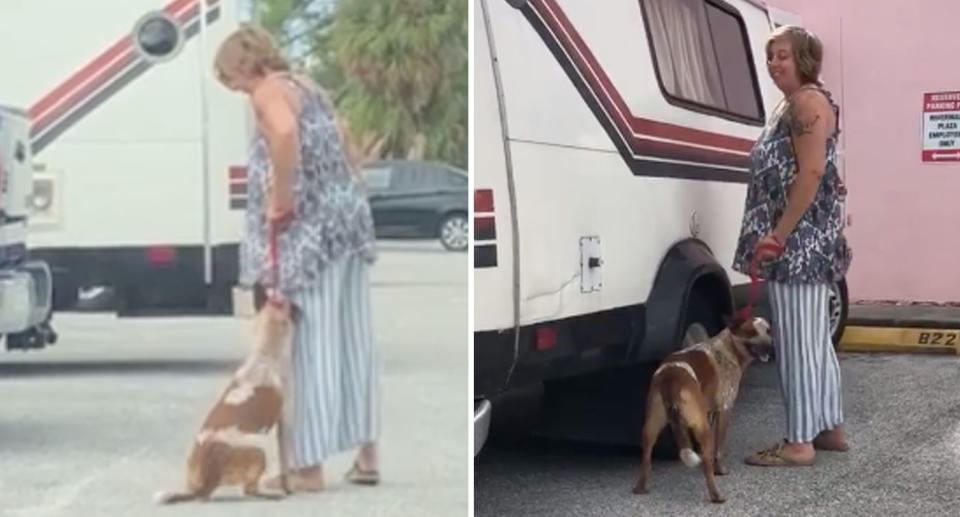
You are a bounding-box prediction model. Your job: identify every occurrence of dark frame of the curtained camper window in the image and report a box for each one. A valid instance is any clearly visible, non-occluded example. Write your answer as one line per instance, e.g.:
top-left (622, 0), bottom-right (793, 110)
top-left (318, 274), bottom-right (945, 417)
top-left (638, 0), bottom-right (766, 127)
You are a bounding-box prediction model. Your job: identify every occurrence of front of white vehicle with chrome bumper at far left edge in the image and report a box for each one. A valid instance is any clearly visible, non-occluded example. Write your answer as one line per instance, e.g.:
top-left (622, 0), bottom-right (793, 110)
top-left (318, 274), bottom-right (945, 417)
top-left (0, 106), bottom-right (56, 350)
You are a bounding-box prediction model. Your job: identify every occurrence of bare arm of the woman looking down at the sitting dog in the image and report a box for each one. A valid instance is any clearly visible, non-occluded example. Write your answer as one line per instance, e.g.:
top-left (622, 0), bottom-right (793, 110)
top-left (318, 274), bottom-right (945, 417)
top-left (253, 79), bottom-right (300, 219)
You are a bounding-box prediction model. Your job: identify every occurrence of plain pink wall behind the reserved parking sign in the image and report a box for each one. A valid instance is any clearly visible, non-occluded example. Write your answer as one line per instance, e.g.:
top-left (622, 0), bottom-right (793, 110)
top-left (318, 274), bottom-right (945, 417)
top-left (768, 0), bottom-right (960, 302)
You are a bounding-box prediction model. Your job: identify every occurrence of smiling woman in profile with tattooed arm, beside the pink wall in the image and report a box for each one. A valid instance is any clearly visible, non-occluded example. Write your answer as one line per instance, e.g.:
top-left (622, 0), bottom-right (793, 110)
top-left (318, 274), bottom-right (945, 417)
top-left (733, 26), bottom-right (851, 466)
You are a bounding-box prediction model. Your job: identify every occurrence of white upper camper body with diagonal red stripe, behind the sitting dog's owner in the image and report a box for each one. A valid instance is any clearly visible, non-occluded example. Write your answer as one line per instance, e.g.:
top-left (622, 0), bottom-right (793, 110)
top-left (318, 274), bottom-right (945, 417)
top-left (0, 0), bottom-right (248, 248)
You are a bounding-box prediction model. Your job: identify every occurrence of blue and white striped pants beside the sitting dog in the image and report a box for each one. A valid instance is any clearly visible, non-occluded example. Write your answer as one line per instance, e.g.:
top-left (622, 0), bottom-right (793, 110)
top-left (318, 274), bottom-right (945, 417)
top-left (287, 256), bottom-right (380, 469)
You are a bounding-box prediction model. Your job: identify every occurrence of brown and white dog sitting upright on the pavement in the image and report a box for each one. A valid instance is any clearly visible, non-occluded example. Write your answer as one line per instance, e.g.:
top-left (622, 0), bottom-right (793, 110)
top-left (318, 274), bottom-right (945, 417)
top-left (154, 300), bottom-right (296, 504)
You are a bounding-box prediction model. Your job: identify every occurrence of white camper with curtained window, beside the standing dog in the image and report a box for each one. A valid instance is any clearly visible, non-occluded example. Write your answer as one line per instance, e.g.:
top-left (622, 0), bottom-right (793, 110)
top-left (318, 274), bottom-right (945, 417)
top-left (473, 0), bottom-right (847, 454)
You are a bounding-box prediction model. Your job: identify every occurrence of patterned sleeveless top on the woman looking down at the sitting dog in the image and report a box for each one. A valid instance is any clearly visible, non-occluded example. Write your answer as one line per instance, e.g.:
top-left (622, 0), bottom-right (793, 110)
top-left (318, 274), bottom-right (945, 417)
top-left (239, 75), bottom-right (376, 293)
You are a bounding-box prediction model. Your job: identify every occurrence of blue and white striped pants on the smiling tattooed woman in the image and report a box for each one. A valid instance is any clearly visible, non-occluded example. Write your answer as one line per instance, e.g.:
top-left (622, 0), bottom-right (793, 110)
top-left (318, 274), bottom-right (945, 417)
top-left (767, 282), bottom-right (843, 443)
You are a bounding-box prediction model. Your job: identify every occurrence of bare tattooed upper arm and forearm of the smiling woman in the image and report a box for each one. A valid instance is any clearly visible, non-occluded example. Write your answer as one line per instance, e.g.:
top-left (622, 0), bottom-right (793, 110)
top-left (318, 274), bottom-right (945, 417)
top-left (773, 90), bottom-right (834, 242)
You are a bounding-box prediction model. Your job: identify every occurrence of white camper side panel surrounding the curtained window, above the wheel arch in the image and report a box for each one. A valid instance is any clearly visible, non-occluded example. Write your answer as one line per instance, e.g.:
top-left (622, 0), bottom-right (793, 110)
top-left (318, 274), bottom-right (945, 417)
top-left (490, 0), bottom-right (771, 325)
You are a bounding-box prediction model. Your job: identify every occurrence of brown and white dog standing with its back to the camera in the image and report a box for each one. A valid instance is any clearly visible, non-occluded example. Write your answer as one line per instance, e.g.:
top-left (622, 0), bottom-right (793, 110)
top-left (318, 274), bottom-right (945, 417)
top-left (633, 317), bottom-right (773, 503)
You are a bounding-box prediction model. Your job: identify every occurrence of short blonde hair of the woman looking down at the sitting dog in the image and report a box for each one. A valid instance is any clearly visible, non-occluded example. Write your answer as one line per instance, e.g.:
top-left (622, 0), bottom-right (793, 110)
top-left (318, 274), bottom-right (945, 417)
top-left (213, 24), bottom-right (290, 82)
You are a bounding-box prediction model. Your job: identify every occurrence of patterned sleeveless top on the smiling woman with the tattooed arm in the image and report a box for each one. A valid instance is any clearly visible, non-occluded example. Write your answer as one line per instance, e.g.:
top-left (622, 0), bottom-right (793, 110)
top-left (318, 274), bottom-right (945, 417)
top-left (733, 86), bottom-right (853, 284)
